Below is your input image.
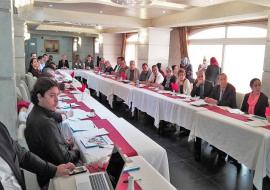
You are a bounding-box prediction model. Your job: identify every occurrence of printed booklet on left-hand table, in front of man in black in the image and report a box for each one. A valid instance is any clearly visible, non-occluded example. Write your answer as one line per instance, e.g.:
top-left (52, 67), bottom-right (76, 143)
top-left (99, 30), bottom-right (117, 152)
top-left (81, 135), bottom-right (113, 148)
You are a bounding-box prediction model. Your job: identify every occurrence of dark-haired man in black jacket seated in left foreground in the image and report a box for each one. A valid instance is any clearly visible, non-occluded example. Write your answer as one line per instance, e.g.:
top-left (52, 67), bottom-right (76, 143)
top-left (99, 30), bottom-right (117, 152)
top-left (25, 77), bottom-right (80, 187)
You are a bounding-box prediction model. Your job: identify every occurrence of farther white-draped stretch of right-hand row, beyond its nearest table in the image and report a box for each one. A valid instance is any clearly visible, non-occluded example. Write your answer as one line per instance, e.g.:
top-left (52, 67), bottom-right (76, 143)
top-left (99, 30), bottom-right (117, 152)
top-left (69, 70), bottom-right (205, 129)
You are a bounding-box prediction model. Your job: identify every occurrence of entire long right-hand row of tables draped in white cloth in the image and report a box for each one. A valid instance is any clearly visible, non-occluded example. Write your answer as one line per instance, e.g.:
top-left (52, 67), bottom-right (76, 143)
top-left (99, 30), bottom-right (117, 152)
top-left (64, 70), bottom-right (270, 189)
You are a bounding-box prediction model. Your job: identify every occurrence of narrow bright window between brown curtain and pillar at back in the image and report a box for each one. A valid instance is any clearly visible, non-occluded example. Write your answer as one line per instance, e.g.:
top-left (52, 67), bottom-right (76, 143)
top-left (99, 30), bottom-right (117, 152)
top-left (125, 34), bottom-right (138, 66)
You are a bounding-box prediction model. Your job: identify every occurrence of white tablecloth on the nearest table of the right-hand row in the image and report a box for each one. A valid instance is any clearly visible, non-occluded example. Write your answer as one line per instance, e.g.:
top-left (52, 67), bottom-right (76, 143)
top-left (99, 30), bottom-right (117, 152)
top-left (190, 111), bottom-right (270, 189)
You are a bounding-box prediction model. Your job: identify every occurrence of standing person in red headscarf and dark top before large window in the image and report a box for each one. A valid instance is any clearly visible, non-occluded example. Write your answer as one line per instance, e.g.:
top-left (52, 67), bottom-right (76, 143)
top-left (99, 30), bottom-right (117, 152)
top-left (205, 57), bottom-right (221, 86)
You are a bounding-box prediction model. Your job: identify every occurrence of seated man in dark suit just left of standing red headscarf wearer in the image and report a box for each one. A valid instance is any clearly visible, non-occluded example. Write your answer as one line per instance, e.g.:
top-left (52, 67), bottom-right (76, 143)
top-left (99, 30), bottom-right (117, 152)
top-left (190, 70), bottom-right (213, 99)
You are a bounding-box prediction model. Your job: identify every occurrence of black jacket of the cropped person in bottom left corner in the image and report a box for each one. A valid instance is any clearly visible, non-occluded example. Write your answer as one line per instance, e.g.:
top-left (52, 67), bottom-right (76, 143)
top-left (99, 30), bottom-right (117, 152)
top-left (0, 122), bottom-right (56, 190)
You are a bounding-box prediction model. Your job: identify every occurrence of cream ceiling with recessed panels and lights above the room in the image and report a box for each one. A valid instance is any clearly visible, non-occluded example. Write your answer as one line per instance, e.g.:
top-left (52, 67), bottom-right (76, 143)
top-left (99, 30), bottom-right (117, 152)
top-left (19, 0), bottom-right (270, 34)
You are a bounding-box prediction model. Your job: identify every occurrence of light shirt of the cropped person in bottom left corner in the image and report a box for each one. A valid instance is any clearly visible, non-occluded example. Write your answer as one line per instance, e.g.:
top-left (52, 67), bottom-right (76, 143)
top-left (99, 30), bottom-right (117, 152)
top-left (0, 157), bottom-right (22, 190)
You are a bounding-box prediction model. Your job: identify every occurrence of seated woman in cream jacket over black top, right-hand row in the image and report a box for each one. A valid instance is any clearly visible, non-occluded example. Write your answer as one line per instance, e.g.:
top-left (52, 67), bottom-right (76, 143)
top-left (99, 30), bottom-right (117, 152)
top-left (177, 69), bottom-right (191, 95)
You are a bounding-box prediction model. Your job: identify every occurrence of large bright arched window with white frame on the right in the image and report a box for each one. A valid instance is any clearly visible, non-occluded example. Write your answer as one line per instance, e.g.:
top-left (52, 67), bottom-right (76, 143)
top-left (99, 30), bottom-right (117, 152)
top-left (188, 23), bottom-right (267, 93)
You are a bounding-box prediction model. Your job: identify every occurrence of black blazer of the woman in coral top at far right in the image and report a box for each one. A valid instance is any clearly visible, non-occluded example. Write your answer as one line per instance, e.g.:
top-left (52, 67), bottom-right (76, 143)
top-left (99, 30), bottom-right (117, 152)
top-left (241, 92), bottom-right (269, 117)
